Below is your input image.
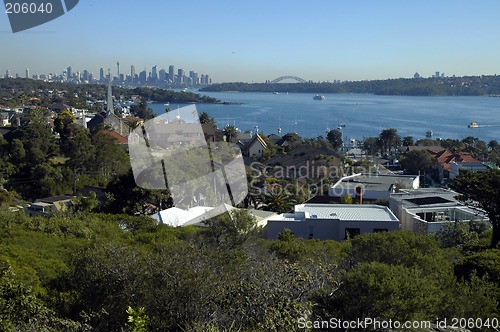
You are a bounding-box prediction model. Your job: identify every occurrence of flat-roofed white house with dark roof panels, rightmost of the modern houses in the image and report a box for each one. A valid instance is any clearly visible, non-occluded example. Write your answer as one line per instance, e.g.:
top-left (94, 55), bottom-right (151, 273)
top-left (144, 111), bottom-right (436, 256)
top-left (389, 188), bottom-right (488, 234)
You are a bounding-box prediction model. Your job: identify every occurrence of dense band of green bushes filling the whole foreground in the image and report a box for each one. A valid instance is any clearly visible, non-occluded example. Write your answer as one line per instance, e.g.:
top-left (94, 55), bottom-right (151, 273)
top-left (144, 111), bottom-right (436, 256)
top-left (0, 211), bottom-right (500, 331)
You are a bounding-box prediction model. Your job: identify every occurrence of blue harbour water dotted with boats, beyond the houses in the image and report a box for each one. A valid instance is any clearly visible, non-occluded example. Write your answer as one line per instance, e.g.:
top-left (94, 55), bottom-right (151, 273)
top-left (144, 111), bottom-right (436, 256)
top-left (149, 92), bottom-right (500, 142)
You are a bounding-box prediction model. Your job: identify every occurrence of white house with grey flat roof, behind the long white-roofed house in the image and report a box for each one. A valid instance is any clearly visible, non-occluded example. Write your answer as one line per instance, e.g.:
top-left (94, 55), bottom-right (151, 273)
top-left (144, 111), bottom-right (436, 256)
top-left (328, 173), bottom-right (420, 201)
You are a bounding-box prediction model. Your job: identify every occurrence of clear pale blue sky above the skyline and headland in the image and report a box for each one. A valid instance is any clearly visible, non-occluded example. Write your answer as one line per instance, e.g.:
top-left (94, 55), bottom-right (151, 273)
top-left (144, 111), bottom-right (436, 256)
top-left (0, 0), bottom-right (500, 82)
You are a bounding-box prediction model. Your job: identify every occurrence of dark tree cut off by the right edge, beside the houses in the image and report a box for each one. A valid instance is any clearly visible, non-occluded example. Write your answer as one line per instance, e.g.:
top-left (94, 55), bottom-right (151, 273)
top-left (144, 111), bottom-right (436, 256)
top-left (451, 169), bottom-right (500, 248)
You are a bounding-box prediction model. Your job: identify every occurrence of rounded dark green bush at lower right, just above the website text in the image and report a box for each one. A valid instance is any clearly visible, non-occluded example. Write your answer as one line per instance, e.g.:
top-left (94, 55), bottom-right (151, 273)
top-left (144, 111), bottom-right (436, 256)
top-left (318, 262), bottom-right (442, 322)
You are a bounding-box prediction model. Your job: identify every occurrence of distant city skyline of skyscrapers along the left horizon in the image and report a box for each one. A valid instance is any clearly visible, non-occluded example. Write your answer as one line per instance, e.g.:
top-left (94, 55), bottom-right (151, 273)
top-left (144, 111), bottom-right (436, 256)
top-left (5, 61), bottom-right (212, 87)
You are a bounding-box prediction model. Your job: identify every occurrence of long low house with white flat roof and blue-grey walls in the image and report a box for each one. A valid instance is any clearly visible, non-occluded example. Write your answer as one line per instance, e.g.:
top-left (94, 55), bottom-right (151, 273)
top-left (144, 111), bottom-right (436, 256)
top-left (264, 203), bottom-right (400, 241)
